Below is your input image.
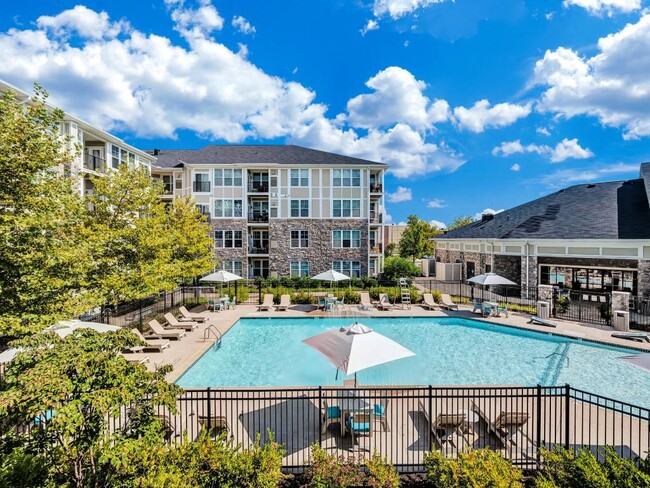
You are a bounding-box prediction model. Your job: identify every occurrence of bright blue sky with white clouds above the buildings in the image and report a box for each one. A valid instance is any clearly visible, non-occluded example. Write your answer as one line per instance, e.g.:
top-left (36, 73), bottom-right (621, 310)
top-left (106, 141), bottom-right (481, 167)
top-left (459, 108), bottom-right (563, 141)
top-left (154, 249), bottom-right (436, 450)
top-left (0, 0), bottom-right (650, 224)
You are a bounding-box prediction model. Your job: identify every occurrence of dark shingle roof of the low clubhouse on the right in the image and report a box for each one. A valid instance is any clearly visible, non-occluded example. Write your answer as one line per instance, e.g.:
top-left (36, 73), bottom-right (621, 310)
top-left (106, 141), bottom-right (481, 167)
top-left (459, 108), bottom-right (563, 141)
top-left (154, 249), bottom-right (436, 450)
top-left (438, 178), bottom-right (650, 239)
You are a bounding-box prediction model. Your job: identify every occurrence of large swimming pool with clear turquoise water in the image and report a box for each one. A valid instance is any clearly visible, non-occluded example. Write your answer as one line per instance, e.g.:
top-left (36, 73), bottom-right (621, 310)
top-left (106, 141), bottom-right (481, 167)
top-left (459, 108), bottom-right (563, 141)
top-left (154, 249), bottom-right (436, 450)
top-left (176, 317), bottom-right (650, 407)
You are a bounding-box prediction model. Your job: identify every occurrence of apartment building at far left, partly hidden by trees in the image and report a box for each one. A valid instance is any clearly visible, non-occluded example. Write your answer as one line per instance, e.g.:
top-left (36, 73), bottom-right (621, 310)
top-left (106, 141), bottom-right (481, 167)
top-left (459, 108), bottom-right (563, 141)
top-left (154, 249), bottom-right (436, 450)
top-left (0, 80), bottom-right (156, 195)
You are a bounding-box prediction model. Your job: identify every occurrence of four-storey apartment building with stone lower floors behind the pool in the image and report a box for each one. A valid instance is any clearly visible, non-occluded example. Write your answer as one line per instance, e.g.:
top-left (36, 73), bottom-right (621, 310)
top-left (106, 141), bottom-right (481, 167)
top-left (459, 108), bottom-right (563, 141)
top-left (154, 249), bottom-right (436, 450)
top-left (151, 145), bottom-right (387, 278)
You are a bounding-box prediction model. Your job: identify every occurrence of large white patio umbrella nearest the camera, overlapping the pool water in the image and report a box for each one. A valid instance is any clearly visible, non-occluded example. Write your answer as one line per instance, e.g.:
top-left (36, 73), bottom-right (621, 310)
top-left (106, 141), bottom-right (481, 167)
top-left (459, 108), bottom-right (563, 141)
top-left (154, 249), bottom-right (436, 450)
top-left (302, 322), bottom-right (415, 379)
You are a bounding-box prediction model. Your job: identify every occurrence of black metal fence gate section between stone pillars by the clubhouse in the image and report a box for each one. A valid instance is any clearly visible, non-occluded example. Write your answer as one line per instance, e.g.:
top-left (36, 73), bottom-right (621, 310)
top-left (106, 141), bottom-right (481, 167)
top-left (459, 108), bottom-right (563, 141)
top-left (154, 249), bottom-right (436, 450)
top-left (553, 290), bottom-right (612, 325)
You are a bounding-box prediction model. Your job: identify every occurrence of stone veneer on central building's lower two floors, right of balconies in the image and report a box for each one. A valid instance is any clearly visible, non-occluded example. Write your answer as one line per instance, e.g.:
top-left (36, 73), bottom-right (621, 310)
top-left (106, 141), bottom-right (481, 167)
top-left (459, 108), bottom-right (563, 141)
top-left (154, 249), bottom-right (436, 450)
top-left (269, 219), bottom-right (368, 276)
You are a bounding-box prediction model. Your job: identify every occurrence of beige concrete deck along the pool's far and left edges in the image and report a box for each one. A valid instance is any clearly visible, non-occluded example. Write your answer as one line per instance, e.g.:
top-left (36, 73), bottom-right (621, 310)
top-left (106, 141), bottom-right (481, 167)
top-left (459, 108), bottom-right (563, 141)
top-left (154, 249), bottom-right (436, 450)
top-left (137, 305), bottom-right (650, 386)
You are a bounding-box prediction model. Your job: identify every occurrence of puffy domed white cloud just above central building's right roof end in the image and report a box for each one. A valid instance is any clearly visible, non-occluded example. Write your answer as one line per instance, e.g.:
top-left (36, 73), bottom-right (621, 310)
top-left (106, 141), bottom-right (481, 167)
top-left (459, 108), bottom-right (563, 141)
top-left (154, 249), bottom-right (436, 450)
top-left (347, 66), bottom-right (449, 129)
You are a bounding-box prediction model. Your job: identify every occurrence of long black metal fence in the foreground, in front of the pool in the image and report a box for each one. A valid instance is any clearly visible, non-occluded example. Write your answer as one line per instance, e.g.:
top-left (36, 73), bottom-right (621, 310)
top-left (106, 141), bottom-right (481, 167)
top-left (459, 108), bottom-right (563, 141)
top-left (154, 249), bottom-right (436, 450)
top-left (101, 385), bottom-right (650, 472)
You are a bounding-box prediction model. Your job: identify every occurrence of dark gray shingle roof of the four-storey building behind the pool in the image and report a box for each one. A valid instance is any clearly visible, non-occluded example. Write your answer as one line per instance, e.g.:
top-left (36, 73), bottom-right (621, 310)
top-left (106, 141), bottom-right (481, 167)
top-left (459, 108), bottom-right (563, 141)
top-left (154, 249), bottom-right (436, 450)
top-left (150, 144), bottom-right (387, 168)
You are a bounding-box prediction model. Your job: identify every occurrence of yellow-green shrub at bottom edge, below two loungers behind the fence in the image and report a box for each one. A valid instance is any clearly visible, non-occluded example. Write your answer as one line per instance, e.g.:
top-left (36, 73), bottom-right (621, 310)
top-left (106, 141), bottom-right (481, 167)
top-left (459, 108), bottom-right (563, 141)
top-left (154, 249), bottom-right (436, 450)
top-left (424, 449), bottom-right (523, 488)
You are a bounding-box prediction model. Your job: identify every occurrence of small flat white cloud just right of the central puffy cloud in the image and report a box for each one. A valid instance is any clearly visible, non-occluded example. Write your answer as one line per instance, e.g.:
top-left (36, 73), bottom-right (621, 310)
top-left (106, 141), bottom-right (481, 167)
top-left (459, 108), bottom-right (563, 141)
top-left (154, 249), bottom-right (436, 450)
top-left (454, 100), bottom-right (532, 133)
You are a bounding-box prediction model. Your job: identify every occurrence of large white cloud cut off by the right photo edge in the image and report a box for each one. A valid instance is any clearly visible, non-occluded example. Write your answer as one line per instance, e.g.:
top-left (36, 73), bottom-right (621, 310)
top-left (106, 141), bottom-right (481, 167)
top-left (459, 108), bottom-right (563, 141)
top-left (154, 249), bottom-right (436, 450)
top-left (533, 14), bottom-right (650, 139)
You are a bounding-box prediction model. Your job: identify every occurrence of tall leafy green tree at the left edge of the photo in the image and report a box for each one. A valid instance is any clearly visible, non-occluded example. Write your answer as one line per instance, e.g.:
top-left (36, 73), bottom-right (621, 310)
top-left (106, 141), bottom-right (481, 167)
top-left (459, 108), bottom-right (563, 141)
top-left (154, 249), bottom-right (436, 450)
top-left (0, 86), bottom-right (97, 336)
